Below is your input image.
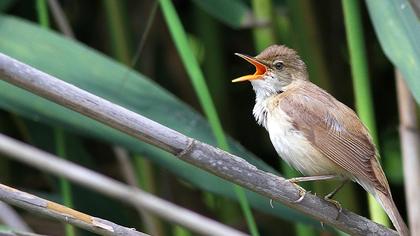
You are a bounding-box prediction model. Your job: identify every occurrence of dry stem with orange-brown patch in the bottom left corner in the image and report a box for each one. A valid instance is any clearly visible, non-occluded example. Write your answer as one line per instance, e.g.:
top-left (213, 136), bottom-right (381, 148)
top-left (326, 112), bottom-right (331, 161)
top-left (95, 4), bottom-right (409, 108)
top-left (0, 184), bottom-right (147, 236)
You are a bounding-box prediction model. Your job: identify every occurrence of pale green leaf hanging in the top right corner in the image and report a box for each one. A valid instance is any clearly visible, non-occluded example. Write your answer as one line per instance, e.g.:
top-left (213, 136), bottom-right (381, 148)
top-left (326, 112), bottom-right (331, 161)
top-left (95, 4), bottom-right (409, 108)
top-left (366, 0), bottom-right (420, 103)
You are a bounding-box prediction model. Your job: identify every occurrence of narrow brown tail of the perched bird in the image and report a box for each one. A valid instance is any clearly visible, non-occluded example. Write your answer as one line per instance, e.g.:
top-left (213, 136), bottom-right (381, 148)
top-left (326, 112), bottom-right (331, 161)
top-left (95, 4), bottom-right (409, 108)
top-left (373, 189), bottom-right (410, 236)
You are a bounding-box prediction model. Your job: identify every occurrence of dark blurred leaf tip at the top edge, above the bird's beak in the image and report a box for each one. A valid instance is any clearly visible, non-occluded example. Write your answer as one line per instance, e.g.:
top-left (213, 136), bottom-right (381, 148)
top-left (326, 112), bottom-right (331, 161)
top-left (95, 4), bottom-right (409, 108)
top-left (192, 0), bottom-right (253, 28)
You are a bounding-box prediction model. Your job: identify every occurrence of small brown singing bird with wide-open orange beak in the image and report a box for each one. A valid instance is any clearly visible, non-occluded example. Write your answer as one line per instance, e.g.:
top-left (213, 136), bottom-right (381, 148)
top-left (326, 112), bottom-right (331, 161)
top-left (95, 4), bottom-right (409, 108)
top-left (232, 45), bottom-right (409, 236)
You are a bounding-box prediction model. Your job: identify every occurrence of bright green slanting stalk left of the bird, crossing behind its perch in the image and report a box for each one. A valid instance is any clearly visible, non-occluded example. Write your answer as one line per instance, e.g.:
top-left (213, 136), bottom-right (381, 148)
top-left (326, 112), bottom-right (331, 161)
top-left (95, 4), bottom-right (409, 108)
top-left (160, 0), bottom-right (259, 236)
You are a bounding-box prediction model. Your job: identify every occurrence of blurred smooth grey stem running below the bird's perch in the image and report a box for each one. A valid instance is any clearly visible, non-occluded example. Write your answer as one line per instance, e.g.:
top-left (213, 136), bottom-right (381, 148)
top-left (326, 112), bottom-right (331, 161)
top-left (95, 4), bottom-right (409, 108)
top-left (0, 134), bottom-right (245, 236)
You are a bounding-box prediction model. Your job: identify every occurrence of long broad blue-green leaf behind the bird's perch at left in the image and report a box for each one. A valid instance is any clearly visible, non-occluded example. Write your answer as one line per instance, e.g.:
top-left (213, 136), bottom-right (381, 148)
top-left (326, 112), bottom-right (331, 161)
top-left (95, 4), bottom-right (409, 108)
top-left (0, 16), bottom-right (318, 225)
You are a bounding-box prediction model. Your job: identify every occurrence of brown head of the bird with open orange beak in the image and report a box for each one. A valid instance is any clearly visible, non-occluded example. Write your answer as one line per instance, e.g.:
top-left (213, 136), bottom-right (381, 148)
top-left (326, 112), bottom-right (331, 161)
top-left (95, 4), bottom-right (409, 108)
top-left (232, 45), bottom-right (308, 96)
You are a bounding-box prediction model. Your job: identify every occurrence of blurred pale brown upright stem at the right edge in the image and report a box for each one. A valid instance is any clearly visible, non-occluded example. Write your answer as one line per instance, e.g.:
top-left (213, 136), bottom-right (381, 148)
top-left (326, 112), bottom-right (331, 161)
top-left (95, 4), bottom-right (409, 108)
top-left (395, 70), bottom-right (420, 235)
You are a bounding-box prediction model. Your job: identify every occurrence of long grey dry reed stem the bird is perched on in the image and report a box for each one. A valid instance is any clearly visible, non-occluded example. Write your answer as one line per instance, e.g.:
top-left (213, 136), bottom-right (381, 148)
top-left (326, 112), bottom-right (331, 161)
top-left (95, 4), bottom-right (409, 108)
top-left (0, 54), bottom-right (396, 235)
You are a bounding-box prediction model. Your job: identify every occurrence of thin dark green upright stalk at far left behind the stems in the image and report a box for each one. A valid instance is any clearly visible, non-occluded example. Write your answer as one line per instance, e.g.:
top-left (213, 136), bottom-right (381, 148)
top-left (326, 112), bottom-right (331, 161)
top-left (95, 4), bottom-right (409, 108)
top-left (36, 0), bottom-right (76, 236)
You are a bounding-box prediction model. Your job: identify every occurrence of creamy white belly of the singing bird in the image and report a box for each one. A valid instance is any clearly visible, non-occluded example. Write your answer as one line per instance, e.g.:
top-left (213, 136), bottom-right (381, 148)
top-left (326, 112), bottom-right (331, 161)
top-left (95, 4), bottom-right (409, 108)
top-left (267, 109), bottom-right (342, 176)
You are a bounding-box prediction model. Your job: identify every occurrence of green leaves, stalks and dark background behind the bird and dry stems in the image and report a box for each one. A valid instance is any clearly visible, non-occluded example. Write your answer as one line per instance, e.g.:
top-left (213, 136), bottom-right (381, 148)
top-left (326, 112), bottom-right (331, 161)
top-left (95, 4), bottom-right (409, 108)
top-left (0, 0), bottom-right (420, 235)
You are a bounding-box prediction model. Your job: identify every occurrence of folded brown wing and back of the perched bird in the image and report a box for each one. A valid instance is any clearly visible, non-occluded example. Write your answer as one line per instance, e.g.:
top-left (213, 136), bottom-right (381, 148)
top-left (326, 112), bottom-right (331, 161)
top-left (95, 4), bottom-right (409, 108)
top-left (277, 85), bottom-right (388, 193)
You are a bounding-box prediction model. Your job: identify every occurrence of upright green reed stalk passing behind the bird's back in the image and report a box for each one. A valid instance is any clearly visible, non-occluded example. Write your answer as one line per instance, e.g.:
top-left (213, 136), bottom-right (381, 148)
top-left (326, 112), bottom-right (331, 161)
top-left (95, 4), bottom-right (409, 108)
top-left (342, 0), bottom-right (389, 226)
